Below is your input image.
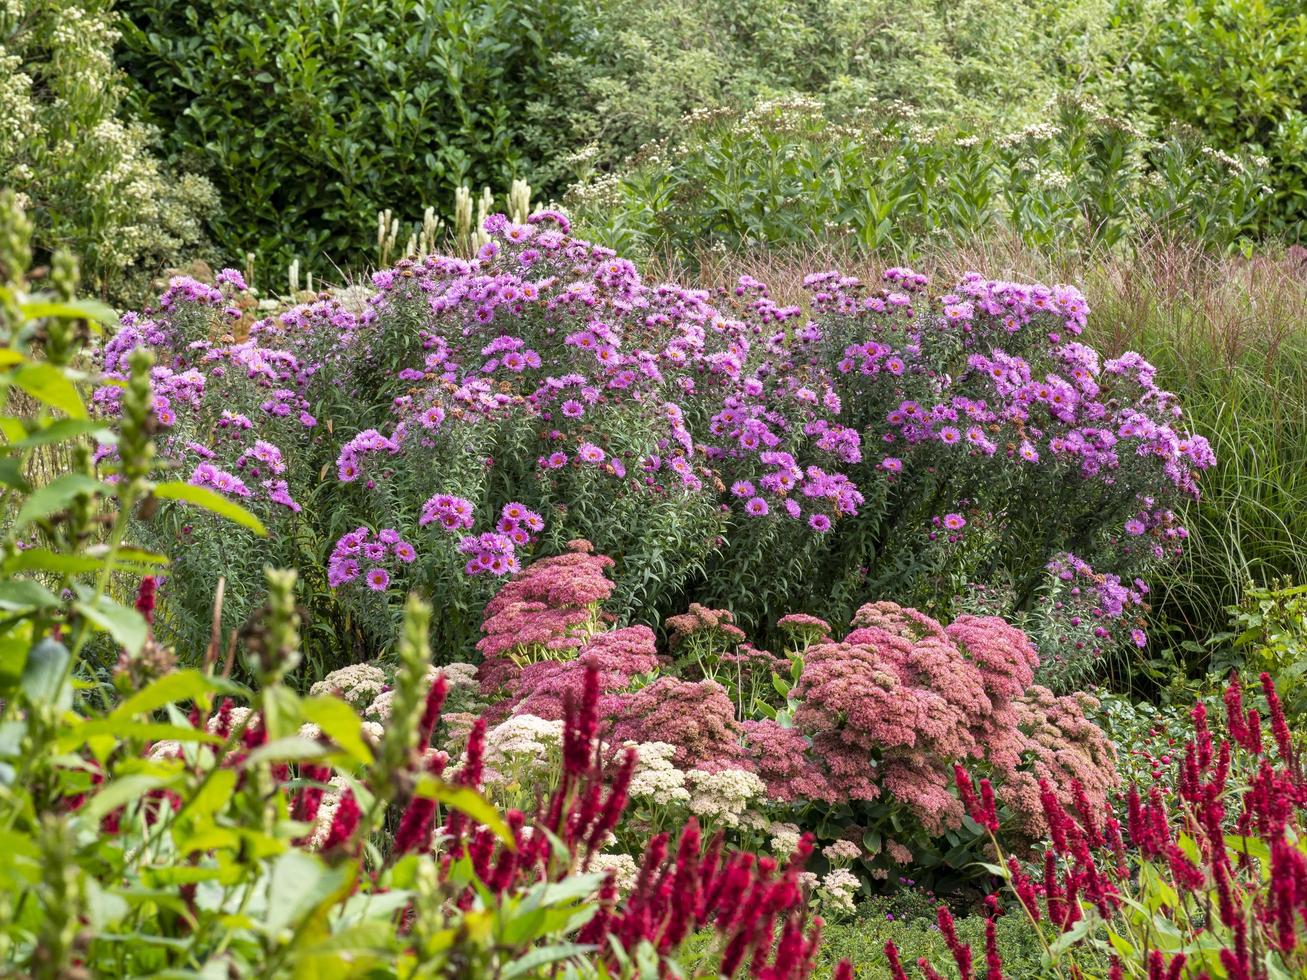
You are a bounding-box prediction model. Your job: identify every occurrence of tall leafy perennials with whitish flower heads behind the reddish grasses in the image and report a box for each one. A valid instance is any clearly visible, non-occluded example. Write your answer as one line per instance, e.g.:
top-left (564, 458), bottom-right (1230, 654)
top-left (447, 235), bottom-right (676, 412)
top-left (569, 97), bottom-right (1264, 260)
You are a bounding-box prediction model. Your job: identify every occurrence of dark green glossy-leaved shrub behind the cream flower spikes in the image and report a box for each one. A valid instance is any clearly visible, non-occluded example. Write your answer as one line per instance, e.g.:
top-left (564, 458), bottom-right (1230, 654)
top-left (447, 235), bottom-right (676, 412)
top-left (119, 0), bottom-right (580, 273)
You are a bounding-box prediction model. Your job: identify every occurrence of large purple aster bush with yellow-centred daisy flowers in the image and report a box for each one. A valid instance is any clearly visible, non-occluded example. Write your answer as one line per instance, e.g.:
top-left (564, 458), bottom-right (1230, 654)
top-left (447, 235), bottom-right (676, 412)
top-left (101, 212), bottom-right (1213, 696)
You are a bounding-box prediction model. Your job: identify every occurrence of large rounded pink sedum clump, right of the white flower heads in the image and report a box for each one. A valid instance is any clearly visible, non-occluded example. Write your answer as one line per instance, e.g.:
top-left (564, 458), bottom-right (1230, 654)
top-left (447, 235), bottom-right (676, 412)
top-left (793, 602), bottom-right (1116, 838)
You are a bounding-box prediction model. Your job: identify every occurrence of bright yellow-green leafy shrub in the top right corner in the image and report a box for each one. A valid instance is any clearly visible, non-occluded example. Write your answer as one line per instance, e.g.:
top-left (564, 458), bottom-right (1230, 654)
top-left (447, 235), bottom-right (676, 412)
top-left (1127, 0), bottom-right (1307, 240)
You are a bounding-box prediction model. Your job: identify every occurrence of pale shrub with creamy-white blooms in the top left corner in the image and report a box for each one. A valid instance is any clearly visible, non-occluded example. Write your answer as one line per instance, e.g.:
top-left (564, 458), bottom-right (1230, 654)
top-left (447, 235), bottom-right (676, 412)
top-left (0, 0), bottom-right (217, 299)
